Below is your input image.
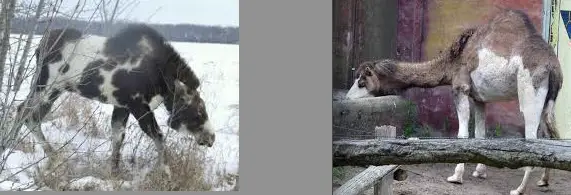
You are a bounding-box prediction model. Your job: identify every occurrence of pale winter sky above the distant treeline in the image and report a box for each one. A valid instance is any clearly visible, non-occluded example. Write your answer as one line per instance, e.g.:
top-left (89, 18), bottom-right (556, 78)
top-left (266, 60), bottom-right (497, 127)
top-left (53, 0), bottom-right (239, 26)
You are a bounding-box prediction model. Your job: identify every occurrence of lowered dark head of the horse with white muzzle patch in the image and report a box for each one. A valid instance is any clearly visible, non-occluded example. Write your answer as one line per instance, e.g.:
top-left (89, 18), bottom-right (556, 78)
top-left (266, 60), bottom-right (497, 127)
top-left (169, 81), bottom-right (215, 147)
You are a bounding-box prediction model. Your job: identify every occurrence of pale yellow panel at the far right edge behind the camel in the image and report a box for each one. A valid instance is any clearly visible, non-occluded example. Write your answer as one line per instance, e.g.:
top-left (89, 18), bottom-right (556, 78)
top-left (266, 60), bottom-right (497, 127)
top-left (555, 0), bottom-right (571, 138)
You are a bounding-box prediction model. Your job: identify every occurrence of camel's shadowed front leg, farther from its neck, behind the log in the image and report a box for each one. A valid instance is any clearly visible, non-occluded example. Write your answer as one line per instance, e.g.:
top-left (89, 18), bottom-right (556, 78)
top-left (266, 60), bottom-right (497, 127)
top-left (472, 101), bottom-right (488, 178)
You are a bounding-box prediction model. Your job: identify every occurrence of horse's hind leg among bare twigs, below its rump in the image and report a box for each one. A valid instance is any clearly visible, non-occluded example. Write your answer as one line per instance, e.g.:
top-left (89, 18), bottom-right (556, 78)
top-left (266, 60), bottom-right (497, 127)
top-left (15, 90), bottom-right (61, 163)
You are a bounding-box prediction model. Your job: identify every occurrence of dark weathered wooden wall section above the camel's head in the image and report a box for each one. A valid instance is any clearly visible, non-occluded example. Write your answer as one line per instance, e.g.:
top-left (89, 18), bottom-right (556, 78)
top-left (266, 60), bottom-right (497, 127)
top-left (332, 0), bottom-right (397, 89)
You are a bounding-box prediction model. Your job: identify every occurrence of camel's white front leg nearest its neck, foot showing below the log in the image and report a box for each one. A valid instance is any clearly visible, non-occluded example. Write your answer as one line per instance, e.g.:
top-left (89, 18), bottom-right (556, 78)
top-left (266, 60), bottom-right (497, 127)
top-left (446, 68), bottom-right (470, 184)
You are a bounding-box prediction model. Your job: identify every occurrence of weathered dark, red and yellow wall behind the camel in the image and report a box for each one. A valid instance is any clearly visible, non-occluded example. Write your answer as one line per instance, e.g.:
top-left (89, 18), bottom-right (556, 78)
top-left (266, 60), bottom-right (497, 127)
top-left (332, 0), bottom-right (571, 140)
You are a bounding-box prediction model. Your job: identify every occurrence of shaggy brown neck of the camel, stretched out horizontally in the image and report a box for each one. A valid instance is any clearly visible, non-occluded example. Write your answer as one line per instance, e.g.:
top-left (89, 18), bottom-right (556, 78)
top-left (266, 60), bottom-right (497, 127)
top-left (395, 55), bottom-right (451, 88)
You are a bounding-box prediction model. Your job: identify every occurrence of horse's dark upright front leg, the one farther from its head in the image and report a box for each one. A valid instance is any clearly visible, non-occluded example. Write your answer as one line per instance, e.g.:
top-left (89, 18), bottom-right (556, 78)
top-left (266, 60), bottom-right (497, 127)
top-left (111, 106), bottom-right (129, 176)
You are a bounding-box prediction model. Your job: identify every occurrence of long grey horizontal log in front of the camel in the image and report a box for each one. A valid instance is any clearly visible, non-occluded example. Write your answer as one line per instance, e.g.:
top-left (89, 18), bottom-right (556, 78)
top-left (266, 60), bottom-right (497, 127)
top-left (333, 138), bottom-right (571, 171)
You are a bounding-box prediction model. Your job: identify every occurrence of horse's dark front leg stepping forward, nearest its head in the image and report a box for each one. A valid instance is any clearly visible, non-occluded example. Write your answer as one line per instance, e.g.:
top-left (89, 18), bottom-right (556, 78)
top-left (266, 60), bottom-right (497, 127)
top-left (125, 104), bottom-right (171, 178)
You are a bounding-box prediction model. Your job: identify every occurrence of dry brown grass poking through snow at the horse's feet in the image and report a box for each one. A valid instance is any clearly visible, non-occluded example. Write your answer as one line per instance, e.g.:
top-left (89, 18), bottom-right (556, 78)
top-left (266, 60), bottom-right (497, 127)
top-left (27, 133), bottom-right (213, 191)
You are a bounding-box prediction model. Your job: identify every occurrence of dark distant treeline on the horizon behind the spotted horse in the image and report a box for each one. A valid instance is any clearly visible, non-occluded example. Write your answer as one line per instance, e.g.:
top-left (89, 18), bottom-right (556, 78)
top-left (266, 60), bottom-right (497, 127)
top-left (11, 18), bottom-right (239, 44)
